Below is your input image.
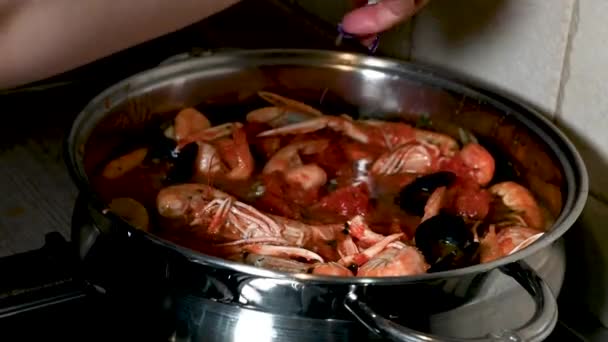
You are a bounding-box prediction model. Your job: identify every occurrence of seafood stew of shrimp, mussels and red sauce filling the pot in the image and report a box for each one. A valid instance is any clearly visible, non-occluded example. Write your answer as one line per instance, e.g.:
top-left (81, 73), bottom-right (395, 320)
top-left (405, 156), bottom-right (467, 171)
top-left (91, 92), bottom-right (554, 277)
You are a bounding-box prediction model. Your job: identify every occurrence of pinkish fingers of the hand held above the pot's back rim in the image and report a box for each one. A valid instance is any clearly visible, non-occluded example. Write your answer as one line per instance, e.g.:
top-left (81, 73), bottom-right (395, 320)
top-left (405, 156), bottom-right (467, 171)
top-left (342, 0), bottom-right (429, 35)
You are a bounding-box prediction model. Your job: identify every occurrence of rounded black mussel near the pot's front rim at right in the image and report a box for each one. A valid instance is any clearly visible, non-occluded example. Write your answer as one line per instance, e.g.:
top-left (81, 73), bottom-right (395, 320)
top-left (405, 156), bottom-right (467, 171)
top-left (415, 212), bottom-right (479, 272)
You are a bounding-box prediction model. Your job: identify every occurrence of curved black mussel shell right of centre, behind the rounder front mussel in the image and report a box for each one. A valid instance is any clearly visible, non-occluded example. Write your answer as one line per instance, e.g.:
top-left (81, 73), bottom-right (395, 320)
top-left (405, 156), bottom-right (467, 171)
top-left (395, 171), bottom-right (456, 216)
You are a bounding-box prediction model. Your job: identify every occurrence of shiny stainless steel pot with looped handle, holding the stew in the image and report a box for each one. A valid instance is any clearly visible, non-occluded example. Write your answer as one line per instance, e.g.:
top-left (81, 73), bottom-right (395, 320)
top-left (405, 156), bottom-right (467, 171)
top-left (66, 50), bottom-right (588, 341)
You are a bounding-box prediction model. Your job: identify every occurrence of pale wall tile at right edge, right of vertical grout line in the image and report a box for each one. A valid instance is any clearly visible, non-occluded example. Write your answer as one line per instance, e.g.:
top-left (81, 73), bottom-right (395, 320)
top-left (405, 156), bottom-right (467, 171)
top-left (558, 0), bottom-right (608, 199)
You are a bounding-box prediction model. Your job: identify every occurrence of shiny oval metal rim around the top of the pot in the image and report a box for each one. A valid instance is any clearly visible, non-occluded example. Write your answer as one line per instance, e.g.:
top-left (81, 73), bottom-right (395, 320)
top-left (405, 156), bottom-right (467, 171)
top-left (64, 49), bottom-right (589, 285)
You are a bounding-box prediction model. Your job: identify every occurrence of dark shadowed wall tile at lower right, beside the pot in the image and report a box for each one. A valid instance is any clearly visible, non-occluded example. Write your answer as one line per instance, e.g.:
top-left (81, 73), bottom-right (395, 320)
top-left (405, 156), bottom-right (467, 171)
top-left (563, 196), bottom-right (608, 326)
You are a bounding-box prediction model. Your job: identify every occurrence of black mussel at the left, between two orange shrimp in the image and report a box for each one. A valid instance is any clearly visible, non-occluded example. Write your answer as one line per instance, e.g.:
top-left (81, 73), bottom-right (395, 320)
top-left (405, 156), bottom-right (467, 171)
top-left (148, 136), bottom-right (198, 184)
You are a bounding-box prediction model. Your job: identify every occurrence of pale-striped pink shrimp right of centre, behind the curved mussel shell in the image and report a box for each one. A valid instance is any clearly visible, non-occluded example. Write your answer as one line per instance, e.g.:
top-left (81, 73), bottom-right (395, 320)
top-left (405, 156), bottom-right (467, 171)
top-left (372, 142), bottom-right (440, 175)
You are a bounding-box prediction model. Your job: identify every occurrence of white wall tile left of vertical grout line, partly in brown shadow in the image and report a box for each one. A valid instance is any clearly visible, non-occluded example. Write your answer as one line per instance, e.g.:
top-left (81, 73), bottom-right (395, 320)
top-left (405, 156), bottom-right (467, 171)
top-left (411, 0), bottom-right (576, 116)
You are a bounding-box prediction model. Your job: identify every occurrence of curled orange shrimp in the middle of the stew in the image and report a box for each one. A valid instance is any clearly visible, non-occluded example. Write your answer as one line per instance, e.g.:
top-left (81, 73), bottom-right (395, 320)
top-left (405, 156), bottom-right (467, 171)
top-left (262, 139), bottom-right (329, 190)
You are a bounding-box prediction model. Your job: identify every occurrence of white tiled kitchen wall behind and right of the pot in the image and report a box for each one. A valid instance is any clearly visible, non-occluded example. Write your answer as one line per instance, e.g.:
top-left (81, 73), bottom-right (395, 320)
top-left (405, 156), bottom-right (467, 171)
top-left (299, 0), bottom-right (608, 326)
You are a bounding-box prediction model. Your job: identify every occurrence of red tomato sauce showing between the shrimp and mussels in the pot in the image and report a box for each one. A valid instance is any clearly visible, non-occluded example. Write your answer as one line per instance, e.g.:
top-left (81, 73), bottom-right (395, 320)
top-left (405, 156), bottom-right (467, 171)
top-left (92, 112), bottom-right (508, 257)
